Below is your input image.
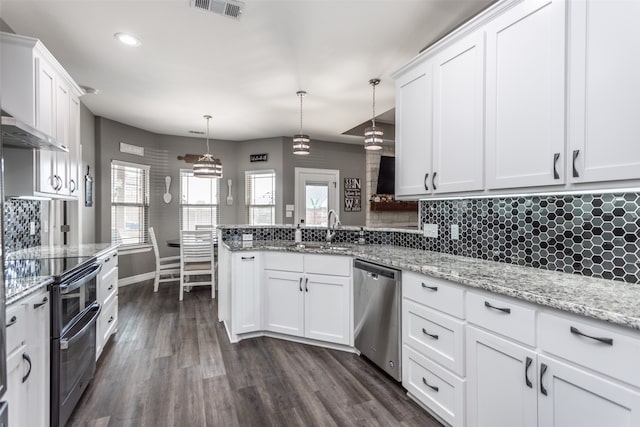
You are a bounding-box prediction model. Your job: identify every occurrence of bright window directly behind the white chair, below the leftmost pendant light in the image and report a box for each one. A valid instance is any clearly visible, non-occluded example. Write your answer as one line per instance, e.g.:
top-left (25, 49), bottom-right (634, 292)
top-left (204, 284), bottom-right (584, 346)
top-left (180, 169), bottom-right (220, 230)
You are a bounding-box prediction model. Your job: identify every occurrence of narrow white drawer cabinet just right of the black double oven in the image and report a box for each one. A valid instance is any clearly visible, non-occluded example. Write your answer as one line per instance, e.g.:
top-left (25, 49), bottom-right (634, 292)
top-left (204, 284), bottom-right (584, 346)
top-left (96, 249), bottom-right (118, 360)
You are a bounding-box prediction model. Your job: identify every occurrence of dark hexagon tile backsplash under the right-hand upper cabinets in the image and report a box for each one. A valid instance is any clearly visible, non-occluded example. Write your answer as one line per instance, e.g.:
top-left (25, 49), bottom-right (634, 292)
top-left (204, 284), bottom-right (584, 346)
top-left (420, 193), bottom-right (640, 283)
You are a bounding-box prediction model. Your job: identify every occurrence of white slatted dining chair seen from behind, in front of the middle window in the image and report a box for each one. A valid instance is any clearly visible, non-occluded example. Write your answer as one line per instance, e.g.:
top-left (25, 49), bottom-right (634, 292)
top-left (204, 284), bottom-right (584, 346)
top-left (180, 230), bottom-right (216, 301)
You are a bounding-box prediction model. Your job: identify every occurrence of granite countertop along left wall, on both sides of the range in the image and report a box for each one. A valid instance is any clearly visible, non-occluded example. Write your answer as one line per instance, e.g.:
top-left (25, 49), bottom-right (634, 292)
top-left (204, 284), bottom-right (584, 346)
top-left (5, 243), bottom-right (118, 305)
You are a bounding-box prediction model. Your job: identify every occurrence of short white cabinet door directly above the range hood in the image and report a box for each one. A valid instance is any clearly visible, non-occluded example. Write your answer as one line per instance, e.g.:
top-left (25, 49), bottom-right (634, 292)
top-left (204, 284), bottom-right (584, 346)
top-left (34, 55), bottom-right (57, 136)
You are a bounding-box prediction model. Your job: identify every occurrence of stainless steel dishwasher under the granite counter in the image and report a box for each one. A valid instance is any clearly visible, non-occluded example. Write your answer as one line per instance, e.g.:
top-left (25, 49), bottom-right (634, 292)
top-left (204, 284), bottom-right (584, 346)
top-left (353, 259), bottom-right (402, 381)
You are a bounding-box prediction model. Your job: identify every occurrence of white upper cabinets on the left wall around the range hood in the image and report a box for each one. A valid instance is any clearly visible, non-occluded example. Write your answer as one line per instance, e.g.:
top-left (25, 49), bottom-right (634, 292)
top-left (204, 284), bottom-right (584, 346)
top-left (0, 33), bottom-right (83, 200)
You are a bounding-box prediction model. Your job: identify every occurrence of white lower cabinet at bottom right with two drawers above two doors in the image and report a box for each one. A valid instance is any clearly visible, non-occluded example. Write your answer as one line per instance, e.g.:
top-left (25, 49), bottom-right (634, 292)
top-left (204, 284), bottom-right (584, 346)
top-left (466, 291), bottom-right (640, 427)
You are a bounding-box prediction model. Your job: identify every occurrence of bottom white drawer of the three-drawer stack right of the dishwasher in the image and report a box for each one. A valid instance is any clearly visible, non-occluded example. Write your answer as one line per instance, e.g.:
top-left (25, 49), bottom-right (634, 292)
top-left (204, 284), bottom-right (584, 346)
top-left (402, 346), bottom-right (465, 427)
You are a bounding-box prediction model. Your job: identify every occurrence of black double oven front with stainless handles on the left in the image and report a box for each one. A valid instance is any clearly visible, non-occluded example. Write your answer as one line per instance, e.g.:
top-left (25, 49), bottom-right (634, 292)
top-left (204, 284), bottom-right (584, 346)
top-left (49, 258), bottom-right (101, 427)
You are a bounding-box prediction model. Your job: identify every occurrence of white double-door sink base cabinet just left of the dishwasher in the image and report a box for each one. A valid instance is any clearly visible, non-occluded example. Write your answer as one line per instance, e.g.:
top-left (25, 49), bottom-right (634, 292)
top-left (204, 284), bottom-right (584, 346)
top-left (263, 253), bottom-right (353, 345)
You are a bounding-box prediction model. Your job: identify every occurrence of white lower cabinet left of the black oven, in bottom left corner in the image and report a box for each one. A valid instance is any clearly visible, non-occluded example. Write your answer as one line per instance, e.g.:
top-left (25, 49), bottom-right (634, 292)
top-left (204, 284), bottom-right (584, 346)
top-left (6, 289), bottom-right (50, 427)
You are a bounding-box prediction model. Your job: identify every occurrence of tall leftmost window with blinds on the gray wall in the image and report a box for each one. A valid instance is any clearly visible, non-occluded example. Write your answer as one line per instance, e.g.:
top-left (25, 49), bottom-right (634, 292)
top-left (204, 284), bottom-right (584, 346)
top-left (111, 160), bottom-right (149, 245)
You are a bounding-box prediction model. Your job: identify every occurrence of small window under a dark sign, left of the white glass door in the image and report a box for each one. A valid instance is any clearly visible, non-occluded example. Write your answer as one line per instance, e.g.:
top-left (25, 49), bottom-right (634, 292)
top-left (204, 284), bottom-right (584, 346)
top-left (244, 170), bottom-right (276, 225)
